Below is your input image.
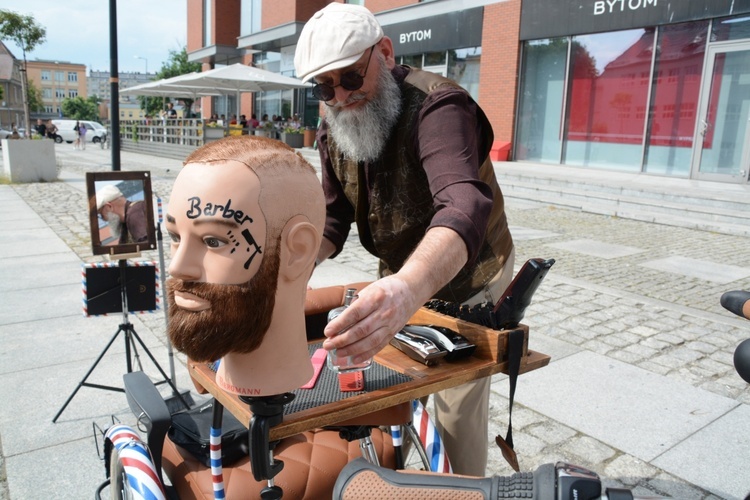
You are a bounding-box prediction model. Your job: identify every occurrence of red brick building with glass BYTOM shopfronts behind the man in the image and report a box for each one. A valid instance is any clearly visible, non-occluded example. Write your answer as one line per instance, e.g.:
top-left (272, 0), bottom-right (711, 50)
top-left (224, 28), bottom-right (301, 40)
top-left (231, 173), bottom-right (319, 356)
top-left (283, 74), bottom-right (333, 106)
top-left (187, 0), bottom-right (750, 183)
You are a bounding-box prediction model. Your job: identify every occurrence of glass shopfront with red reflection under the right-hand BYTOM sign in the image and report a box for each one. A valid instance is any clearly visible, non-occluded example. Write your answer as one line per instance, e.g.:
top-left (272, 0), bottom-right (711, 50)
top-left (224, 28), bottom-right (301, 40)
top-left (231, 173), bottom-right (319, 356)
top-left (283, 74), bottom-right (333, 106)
top-left (514, 0), bottom-right (750, 183)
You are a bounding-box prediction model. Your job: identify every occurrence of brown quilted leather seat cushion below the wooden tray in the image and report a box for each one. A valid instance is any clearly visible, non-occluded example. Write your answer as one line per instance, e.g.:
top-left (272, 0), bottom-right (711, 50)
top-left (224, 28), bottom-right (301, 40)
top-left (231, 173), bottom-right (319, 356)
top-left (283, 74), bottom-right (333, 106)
top-left (162, 429), bottom-right (395, 500)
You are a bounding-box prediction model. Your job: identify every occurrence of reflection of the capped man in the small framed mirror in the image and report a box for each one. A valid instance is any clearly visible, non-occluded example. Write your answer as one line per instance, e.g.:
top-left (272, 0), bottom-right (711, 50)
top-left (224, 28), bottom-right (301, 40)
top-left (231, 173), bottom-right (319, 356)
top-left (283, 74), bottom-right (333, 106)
top-left (96, 184), bottom-right (148, 245)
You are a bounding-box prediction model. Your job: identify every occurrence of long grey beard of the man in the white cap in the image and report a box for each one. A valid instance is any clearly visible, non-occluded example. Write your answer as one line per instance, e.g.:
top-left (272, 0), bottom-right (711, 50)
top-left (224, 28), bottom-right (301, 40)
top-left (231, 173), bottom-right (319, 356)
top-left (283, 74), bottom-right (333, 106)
top-left (326, 59), bottom-right (401, 161)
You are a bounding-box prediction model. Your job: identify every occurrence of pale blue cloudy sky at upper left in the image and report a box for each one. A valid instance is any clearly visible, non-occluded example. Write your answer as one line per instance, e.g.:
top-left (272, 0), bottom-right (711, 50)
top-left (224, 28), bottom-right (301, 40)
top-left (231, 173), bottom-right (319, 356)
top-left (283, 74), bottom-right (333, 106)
top-left (0, 0), bottom-right (187, 73)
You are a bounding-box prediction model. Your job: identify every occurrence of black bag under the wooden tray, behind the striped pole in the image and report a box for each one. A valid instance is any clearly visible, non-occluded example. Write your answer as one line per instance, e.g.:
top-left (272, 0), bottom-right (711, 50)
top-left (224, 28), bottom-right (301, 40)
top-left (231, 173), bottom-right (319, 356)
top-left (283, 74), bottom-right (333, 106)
top-left (169, 400), bottom-right (250, 467)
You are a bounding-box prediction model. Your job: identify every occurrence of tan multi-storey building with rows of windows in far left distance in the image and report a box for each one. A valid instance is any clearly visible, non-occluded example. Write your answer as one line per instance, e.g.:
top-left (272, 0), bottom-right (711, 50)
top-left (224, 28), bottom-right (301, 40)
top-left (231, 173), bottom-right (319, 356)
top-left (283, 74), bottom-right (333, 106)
top-left (26, 59), bottom-right (88, 116)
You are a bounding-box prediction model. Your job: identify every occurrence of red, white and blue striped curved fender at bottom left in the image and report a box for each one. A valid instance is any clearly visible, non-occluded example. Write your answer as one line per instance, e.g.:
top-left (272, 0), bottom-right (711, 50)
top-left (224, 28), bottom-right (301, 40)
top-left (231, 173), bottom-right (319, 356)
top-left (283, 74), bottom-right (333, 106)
top-left (106, 425), bottom-right (166, 500)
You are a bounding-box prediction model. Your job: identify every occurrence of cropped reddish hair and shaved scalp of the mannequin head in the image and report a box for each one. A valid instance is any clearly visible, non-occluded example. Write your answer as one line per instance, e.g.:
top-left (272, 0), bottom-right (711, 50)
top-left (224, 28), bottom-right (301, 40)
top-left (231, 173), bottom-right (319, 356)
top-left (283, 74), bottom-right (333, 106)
top-left (184, 135), bottom-right (325, 237)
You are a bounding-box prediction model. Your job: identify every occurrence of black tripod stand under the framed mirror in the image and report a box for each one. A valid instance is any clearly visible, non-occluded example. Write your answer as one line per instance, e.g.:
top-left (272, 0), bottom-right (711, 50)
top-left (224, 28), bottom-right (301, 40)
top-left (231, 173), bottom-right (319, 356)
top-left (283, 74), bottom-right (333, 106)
top-left (52, 259), bottom-right (190, 423)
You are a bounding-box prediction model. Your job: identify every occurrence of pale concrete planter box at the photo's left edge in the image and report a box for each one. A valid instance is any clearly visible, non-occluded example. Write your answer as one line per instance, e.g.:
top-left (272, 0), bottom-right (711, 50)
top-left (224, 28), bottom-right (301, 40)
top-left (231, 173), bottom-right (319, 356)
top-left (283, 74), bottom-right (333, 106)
top-left (3, 139), bottom-right (57, 182)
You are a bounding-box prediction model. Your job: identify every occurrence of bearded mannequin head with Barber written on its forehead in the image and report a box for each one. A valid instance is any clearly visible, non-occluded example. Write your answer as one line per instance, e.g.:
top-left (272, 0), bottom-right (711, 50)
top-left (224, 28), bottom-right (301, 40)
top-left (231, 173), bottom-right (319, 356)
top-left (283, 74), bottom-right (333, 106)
top-left (166, 136), bottom-right (325, 396)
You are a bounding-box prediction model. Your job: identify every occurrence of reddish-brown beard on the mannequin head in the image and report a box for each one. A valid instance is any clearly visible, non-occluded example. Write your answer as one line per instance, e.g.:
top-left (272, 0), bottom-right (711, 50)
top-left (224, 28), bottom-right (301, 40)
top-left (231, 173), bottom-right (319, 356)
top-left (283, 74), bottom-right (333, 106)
top-left (167, 238), bottom-right (280, 362)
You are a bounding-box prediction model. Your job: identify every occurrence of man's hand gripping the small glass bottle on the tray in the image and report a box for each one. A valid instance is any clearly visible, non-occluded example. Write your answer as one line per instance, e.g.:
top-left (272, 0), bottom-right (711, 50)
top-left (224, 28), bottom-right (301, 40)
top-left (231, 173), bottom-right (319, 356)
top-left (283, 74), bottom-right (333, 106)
top-left (323, 275), bottom-right (422, 364)
